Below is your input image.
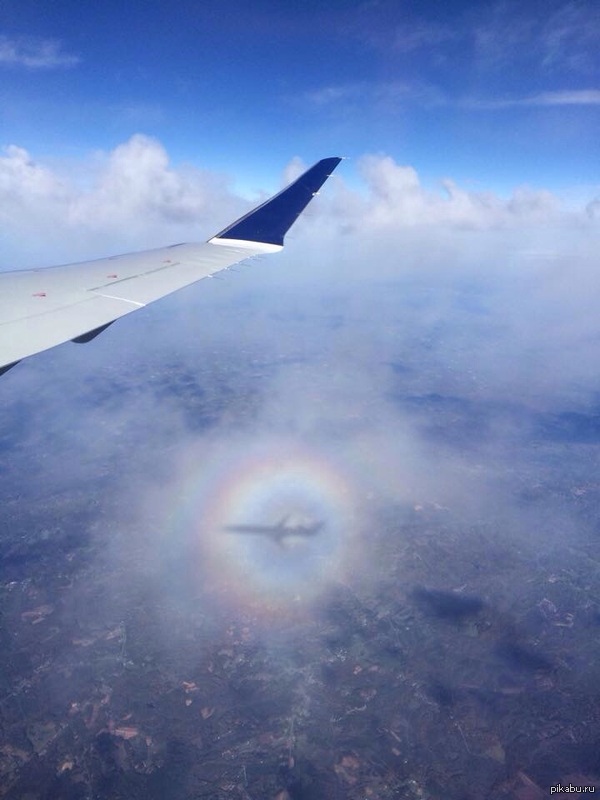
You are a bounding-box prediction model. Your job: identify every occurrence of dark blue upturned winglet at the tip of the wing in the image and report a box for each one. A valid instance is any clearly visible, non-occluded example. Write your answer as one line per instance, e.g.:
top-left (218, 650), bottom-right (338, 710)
top-left (214, 158), bottom-right (342, 245)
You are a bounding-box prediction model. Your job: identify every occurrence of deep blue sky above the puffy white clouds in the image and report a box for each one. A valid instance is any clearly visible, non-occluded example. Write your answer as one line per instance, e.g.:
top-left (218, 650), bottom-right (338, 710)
top-left (0, 0), bottom-right (600, 192)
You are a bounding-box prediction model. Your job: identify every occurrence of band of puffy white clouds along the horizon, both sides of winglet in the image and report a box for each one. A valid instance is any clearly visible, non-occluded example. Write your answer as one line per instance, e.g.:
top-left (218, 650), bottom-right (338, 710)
top-left (0, 134), bottom-right (596, 268)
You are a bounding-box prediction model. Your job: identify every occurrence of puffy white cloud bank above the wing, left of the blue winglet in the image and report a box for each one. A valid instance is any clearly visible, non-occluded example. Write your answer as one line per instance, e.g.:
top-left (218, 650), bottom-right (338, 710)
top-left (0, 134), bottom-right (243, 267)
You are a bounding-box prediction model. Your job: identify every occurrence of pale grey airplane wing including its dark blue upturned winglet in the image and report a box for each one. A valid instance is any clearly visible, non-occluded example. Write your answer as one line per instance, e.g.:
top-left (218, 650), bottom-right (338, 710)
top-left (0, 158), bottom-right (341, 375)
